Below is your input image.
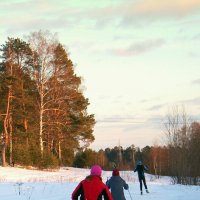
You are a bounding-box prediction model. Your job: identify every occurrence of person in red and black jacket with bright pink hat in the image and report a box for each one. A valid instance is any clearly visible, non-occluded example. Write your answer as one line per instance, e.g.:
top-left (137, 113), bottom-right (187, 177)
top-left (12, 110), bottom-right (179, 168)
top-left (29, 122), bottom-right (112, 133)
top-left (72, 165), bottom-right (113, 200)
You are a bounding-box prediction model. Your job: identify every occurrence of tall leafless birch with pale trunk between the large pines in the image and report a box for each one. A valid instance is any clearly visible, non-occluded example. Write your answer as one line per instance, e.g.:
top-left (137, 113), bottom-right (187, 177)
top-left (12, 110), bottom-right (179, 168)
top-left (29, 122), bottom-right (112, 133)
top-left (29, 31), bottom-right (58, 156)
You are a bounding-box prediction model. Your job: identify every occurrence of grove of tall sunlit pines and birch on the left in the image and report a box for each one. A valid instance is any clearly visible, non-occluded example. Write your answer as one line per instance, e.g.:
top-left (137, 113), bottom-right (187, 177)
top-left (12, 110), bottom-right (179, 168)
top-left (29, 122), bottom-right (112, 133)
top-left (0, 31), bottom-right (95, 167)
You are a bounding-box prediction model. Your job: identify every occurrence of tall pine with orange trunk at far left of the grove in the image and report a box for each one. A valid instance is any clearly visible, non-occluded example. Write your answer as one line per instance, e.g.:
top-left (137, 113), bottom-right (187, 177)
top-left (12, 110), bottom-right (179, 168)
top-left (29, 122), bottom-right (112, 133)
top-left (0, 38), bottom-right (36, 166)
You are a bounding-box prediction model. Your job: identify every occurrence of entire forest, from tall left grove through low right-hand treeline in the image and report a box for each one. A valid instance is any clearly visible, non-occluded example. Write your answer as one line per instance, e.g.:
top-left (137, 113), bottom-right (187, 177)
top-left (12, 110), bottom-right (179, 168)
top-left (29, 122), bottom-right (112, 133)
top-left (0, 31), bottom-right (200, 185)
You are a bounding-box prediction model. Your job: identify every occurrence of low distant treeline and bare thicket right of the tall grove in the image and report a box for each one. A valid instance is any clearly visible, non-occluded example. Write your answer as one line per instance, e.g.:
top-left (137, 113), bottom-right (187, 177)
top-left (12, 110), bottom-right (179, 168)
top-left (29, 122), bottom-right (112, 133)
top-left (73, 119), bottom-right (200, 185)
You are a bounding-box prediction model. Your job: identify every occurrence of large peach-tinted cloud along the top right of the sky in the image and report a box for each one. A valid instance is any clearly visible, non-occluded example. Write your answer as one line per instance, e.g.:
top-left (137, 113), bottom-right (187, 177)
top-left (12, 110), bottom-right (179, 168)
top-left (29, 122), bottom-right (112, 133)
top-left (83, 0), bottom-right (200, 26)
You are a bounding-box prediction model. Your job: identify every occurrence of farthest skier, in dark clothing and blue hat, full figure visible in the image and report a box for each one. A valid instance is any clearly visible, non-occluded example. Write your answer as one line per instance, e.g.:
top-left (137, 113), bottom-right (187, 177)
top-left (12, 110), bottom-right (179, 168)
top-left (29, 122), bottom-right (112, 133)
top-left (134, 160), bottom-right (149, 195)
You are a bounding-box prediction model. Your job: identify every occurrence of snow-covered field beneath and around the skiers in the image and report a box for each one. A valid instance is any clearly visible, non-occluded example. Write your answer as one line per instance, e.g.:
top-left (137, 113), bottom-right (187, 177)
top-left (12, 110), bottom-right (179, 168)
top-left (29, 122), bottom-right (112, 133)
top-left (0, 167), bottom-right (200, 200)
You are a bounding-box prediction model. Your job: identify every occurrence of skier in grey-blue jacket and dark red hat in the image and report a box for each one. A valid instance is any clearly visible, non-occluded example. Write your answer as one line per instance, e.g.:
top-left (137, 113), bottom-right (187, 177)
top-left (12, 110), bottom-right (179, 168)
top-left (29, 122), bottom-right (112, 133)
top-left (106, 169), bottom-right (129, 200)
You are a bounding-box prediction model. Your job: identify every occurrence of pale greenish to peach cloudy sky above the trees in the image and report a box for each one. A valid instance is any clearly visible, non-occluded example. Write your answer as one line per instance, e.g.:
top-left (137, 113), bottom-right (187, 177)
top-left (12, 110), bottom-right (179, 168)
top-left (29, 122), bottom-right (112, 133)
top-left (0, 0), bottom-right (200, 150)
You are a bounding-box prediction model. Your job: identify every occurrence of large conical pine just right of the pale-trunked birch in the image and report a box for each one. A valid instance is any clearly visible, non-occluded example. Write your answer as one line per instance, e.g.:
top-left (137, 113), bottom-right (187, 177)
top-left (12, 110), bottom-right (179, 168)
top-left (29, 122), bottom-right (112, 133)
top-left (47, 44), bottom-right (95, 161)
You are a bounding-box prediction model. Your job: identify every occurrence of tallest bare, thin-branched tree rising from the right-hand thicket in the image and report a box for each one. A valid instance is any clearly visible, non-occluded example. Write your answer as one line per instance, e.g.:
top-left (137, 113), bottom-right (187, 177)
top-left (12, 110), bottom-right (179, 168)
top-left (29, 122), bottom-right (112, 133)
top-left (164, 106), bottom-right (190, 183)
